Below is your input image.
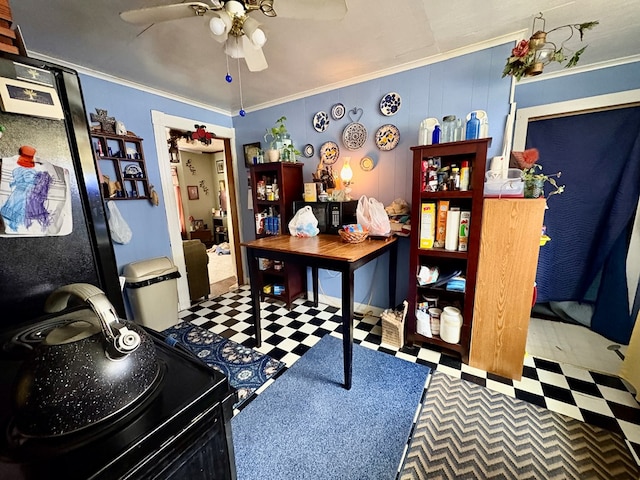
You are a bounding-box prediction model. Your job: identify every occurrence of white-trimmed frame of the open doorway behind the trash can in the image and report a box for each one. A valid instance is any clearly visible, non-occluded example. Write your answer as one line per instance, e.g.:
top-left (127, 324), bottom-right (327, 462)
top-left (151, 111), bottom-right (246, 310)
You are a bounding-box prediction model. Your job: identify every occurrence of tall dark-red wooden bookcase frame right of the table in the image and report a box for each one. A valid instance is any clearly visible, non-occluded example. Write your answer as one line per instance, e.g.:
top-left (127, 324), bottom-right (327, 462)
top-left (406, 138), bottom-right (491, 363)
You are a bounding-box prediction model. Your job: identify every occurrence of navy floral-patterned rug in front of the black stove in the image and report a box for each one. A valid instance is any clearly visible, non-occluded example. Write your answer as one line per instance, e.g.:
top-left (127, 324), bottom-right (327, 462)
top-left (162, 322), bottom-right (285, 408)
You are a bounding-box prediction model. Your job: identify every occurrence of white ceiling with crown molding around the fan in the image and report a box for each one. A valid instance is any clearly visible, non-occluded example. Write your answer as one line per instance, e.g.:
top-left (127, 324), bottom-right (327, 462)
top-left (11, 0), bottom-right (640, 115)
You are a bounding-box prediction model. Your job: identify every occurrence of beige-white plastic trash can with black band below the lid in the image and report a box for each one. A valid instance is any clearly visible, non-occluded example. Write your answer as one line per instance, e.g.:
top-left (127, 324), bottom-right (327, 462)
top-left (123, 257), bottom-right (180, 332)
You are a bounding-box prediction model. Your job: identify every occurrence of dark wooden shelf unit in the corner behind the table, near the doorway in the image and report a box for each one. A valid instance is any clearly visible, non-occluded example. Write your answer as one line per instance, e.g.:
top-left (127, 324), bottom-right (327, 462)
top-left (249, 162), bottom-right (307, 309)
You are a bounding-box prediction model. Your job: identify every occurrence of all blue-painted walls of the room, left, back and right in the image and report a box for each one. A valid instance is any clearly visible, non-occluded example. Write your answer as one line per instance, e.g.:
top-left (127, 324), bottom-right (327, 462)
top-left (81, 44), bottom-right (640, 312)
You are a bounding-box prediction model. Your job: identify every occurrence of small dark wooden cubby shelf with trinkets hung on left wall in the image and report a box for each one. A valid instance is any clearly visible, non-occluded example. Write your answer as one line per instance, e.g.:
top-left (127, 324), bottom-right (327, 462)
top-left (91, 129), bottom-right (149, 200)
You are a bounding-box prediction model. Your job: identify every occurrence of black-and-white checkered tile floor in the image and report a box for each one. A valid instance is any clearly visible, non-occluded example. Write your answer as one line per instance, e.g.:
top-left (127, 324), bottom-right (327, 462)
top-left (180, 286), bottom-right (640, 463)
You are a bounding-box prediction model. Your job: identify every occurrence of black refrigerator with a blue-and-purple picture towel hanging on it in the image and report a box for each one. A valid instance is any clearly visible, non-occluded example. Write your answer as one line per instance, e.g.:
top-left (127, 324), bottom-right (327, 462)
top-left (0, 51), bottom-right (125, 318)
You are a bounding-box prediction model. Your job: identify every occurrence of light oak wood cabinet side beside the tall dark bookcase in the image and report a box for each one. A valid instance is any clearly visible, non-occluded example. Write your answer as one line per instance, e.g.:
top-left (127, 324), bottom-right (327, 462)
top-left (469, 198), bottom-right (546, 380)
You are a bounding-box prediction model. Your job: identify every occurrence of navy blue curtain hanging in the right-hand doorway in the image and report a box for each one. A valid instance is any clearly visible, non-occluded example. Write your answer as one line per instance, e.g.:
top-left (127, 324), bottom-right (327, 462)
top-left (526, 107), bottom-right (640, 343)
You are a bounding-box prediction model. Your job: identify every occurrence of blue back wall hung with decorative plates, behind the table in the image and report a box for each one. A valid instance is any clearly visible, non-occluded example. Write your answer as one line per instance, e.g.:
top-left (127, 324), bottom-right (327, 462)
top-left (233, 45), bottom-right (512, 307)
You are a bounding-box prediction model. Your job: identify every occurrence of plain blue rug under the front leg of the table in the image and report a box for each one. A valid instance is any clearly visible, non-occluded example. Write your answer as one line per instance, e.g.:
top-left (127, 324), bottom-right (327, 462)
top-left (231, 335), bottom-right (430, 480)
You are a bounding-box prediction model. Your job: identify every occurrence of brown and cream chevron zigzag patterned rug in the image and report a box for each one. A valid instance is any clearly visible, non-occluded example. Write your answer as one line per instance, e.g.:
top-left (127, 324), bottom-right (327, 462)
top-left (398, 372), bottom-right (640, 480)
